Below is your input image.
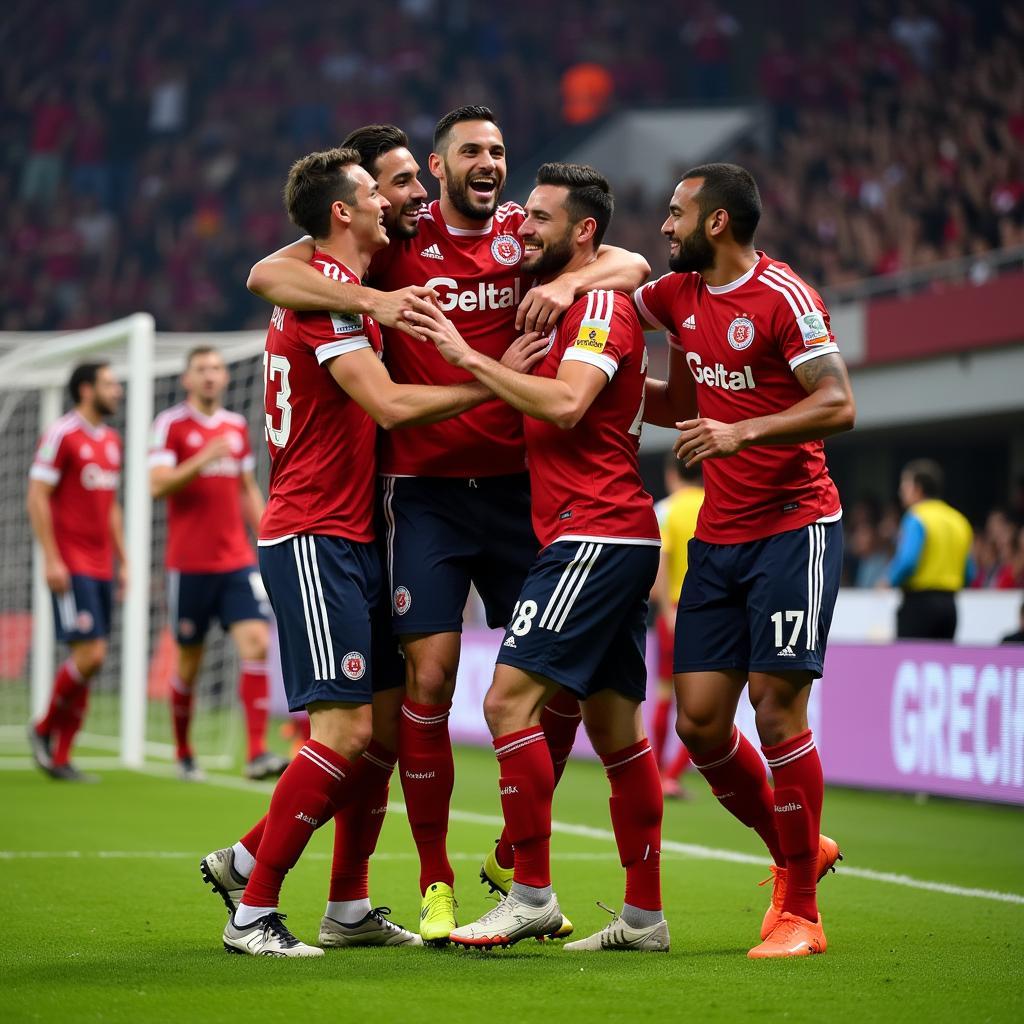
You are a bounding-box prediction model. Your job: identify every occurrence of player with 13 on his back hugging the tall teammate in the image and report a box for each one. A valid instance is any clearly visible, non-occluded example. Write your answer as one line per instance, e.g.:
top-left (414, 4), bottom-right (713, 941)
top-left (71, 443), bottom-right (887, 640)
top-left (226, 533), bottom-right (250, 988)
top-left (202, 150), bottom-right (532, 956)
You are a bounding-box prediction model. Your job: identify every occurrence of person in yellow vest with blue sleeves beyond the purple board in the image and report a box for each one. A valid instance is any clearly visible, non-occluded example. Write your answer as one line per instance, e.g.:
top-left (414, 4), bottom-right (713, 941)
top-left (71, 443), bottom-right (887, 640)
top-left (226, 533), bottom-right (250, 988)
top-left (889, 459), bottom-right (974, 640)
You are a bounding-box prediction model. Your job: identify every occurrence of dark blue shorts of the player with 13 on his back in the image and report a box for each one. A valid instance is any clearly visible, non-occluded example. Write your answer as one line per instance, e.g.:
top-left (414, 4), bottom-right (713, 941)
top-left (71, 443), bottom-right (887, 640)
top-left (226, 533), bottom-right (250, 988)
top-left (259, 535), bottom-right (404, 712)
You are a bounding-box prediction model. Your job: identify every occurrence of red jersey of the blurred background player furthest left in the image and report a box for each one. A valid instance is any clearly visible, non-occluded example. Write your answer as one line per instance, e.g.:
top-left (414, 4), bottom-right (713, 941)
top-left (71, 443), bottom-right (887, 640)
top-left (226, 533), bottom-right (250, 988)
top-left (29, 410), bottom-right (121, 580)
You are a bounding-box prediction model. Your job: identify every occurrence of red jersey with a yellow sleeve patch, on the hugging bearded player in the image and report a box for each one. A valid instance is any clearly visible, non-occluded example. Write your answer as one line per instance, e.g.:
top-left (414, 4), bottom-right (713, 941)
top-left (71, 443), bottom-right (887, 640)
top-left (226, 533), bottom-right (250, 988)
top-left (524, 291), bottom-right (660, 547)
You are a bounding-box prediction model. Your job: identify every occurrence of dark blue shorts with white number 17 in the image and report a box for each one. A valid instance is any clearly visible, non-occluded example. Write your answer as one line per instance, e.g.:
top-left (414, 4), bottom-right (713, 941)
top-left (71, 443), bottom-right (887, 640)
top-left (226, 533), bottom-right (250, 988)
top-left (673, 522), bottom-right (843, 678)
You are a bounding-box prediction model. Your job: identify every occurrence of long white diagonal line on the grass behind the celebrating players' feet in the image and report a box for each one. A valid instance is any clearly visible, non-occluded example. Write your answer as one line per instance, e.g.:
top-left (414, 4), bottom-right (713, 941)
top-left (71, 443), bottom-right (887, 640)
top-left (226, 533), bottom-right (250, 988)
top-left (0, 765), bottom-right (1024, 906)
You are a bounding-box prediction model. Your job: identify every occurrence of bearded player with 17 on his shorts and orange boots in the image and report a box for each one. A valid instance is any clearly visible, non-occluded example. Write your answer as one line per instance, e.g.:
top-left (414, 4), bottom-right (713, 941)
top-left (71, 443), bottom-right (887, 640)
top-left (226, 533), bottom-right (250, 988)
top-left (635, 164), bottom-right (854, 958)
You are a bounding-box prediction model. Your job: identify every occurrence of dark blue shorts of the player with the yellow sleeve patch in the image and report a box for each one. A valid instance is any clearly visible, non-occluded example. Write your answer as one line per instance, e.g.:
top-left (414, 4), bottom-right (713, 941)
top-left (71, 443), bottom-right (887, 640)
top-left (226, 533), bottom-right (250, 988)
top-left (498, 541), bottom-right (659, 701)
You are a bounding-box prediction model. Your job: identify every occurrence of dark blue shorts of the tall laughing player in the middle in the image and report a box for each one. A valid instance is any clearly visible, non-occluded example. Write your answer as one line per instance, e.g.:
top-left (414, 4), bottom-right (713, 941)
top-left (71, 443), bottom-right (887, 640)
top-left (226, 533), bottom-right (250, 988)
top-left (381, 473), bottom-right (538, 636)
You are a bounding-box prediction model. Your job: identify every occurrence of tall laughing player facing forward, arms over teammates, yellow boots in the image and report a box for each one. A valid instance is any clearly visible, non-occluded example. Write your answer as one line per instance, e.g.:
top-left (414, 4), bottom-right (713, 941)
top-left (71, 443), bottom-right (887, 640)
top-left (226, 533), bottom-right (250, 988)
top-left (250, 106), bottom-right (649, 943)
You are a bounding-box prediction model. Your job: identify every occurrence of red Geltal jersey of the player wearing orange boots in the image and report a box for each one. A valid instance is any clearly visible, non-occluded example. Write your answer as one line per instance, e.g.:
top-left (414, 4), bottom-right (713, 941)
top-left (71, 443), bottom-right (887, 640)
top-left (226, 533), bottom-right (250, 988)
top-left (634, 253), bottom-right (842, 544)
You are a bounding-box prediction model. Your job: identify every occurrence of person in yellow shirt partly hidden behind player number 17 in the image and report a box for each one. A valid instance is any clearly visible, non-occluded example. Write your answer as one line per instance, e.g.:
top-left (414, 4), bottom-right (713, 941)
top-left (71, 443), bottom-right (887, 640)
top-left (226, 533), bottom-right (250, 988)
top-left (651, 452), bottom-right (703, 798)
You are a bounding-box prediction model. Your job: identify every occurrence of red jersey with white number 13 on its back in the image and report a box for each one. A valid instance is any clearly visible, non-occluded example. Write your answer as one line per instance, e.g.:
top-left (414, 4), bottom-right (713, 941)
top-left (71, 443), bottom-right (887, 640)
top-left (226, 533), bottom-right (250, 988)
top-left (259, 250), bottom-right (382, 545)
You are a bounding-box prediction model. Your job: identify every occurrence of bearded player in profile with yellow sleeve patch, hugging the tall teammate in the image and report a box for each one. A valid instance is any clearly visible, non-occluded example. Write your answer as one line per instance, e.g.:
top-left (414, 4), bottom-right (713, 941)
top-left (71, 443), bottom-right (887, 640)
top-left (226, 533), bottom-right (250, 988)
top-left (411, 164), bottom-right (669, 951)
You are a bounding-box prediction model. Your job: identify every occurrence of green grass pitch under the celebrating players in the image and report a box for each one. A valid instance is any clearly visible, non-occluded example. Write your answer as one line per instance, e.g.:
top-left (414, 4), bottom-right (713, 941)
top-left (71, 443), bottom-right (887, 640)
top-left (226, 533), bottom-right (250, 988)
top-left (0, 750), bottom-right (1024, 1024)
